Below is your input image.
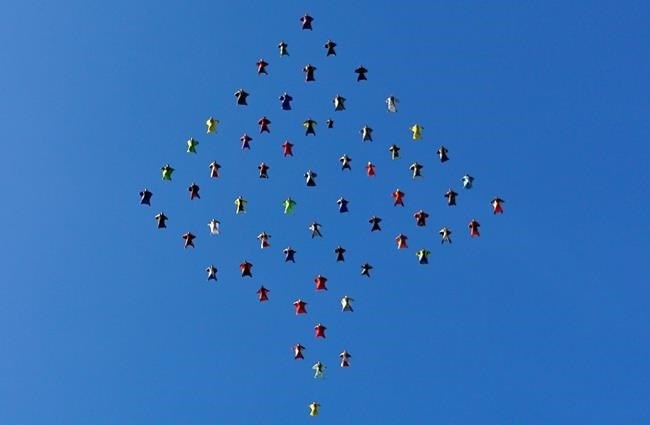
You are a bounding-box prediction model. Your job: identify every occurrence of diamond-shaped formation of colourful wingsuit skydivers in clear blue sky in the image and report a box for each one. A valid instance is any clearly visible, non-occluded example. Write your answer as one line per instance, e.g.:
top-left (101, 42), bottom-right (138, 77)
top-left (139, 8), bottom-right (505, 416)
